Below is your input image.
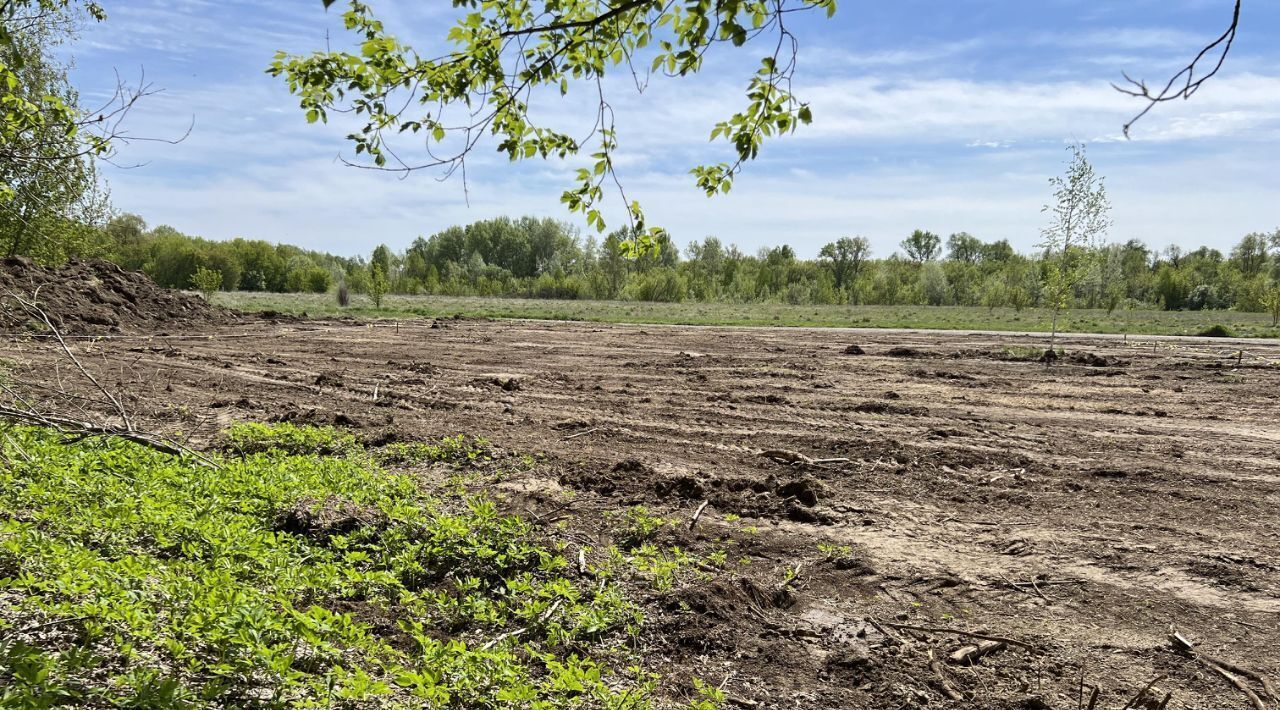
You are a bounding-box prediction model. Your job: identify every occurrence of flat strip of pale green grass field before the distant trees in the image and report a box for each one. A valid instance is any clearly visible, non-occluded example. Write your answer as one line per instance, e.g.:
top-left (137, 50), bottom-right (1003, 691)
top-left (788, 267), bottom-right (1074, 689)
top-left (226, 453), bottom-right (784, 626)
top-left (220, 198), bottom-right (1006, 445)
top-left (214, 292), bottom-right (1280, 338)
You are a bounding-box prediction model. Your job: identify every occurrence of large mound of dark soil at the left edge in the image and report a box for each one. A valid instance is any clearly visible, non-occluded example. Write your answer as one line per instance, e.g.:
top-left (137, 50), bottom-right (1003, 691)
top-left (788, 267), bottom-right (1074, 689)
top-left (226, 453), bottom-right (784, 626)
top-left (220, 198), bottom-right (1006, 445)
top-left (0, 257), bottom-right (236, 335)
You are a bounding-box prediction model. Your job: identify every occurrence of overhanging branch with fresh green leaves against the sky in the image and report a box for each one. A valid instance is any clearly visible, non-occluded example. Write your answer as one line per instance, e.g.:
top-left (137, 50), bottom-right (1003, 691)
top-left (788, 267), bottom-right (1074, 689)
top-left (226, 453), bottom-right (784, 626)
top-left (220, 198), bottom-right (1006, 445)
top-left (268, 0), bottom-right (836, 244)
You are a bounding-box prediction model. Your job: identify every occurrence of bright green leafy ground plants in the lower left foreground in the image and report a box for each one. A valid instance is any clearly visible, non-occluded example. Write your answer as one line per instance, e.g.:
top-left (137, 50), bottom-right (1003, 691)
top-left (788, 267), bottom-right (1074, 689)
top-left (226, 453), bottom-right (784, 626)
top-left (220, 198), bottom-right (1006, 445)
top-left (0, 425), bottom-right (655, 707)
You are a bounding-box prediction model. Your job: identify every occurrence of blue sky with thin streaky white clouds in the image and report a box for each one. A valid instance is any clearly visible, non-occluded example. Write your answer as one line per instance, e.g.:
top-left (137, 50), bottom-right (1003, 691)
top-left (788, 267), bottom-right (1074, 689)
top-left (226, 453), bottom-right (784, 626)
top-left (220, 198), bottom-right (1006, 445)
top-left (72, 0), bottom-right (1280, 256)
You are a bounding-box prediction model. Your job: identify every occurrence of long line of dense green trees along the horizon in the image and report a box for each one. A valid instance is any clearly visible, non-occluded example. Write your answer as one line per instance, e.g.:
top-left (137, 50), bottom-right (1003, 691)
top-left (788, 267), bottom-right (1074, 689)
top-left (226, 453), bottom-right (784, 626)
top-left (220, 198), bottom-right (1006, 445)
top-left (0, 214), bottom-right (1280, 317)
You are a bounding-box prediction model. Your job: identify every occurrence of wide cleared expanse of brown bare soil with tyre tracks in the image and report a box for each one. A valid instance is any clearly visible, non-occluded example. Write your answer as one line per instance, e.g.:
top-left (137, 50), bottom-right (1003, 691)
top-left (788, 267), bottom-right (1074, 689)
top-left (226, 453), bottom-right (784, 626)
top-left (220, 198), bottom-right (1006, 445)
top-left (0, 319), bottom-right (1280, 710)
